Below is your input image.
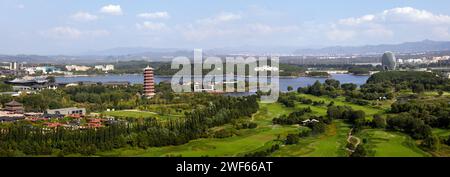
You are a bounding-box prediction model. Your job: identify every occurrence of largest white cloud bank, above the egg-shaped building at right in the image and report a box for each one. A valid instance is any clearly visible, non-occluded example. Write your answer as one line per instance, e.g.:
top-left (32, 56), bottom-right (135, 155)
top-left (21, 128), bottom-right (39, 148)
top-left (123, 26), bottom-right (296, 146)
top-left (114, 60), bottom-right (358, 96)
top-left (327, 7), bottom-right (450, 42)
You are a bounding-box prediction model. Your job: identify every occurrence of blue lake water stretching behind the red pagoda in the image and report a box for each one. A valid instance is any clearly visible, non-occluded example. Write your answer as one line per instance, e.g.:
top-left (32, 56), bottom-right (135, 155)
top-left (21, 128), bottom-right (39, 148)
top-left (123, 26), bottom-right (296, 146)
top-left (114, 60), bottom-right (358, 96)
top-left (55, 74), bottom-right (369, 91)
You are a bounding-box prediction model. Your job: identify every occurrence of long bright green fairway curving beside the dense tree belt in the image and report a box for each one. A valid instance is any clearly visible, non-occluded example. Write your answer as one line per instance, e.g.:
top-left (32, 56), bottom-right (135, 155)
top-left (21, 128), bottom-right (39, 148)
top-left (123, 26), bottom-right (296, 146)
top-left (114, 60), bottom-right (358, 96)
top-left (98, 103), bottom-right (299, 157)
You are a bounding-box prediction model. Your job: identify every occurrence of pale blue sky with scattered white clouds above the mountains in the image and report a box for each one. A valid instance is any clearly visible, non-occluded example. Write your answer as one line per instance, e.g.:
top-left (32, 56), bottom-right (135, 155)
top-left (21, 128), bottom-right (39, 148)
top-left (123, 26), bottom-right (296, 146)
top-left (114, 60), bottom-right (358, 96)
top-left (0, 0), bottom-right (450, 55)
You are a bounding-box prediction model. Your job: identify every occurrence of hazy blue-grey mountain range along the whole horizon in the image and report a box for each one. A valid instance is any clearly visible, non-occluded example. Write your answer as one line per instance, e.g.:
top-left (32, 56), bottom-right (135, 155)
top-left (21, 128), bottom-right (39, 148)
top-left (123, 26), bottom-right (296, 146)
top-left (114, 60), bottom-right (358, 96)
top-left (0, 40), bottom-right (450, 63)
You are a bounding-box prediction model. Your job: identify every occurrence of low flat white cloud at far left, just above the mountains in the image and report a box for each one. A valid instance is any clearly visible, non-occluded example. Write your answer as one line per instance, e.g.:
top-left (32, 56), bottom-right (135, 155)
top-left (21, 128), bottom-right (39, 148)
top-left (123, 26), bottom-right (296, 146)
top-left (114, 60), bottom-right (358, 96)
top-left (42, 26), bottom-right (109, 39)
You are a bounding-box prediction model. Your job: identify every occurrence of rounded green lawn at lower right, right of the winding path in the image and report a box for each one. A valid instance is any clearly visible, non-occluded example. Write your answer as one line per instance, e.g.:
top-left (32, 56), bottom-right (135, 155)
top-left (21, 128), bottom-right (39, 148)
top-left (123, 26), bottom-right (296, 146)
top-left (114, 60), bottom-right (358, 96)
top-left (357, 129), bottom-right (430, 157)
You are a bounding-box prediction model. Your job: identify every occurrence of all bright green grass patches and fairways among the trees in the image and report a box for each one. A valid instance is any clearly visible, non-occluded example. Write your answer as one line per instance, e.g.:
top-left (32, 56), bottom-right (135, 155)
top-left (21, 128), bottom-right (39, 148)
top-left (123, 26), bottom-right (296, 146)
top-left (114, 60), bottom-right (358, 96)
top-left (97, 94), bottom-right (450, 157)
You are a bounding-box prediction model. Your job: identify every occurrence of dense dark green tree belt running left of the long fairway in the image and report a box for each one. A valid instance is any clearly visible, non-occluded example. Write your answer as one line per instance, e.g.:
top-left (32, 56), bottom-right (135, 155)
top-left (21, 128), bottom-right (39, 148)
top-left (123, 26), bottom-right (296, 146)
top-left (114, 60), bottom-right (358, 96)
top-left (0, 96), bottom-right (259, 156)
